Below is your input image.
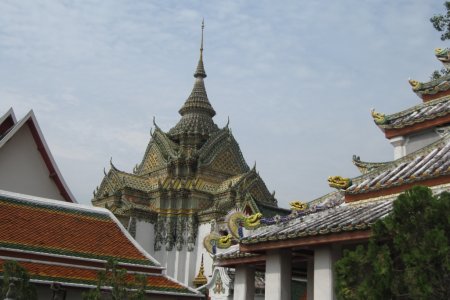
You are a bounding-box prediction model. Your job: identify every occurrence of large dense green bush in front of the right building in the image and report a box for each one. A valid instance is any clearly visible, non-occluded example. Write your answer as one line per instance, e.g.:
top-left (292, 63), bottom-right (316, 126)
top-left (335, 187), bottom-right (450, 300)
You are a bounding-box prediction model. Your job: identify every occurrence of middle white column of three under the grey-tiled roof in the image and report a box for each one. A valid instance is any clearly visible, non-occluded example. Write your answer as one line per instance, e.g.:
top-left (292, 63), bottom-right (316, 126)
top-left (264, 249), bottom-right (292, 300)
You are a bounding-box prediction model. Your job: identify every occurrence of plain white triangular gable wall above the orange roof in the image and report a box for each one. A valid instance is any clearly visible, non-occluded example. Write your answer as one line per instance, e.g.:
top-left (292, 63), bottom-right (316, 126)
top-left (0, 125), bottom-right (64, 200)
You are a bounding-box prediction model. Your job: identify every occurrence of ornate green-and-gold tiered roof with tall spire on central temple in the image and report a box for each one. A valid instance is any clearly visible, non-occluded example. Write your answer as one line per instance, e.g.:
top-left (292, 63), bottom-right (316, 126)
top-left (92, 24), bottom-right (280, 227)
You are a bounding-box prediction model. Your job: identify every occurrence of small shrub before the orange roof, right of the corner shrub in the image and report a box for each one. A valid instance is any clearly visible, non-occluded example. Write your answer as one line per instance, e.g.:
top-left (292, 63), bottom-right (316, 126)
top-left (83, 259), bottom-right (147, 300)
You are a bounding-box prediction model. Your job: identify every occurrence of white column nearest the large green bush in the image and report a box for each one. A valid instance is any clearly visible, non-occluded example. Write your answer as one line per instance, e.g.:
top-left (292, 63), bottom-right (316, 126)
top-left (314, 246), bottom-right (336, 300)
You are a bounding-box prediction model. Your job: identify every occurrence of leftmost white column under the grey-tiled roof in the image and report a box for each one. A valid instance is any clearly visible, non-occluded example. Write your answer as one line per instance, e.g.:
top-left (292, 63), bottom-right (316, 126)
top-left (233, 265), bottom-right (255, 300)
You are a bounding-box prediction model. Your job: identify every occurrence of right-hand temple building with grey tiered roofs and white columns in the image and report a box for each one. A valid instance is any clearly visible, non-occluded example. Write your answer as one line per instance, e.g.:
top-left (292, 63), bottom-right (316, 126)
top-left (213, 49), bottom-right (450, 300)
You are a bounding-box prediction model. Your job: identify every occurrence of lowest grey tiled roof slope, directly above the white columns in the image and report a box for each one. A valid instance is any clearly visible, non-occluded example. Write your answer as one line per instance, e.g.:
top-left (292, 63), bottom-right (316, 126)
top-left (241, 200), bottom-right (392, 245)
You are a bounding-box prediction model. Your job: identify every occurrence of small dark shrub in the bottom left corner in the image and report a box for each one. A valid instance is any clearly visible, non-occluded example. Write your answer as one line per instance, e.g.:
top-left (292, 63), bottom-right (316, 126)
top-left (1, 260), bottom-right (37, 300)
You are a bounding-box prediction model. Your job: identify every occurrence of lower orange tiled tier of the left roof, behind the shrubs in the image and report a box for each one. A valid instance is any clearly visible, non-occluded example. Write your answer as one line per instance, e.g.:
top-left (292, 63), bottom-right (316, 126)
top-left (0, 259), bottom-right (197, 296)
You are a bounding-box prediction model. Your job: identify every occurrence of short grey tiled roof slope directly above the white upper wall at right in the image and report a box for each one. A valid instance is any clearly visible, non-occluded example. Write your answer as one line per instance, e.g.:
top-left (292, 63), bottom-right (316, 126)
top-left (378, 96), bottom-right (450, 129)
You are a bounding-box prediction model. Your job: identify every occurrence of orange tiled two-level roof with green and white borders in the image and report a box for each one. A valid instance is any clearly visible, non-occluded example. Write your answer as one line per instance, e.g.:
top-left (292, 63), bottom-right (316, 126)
top-left (0, 191), bottom-right (201, 297)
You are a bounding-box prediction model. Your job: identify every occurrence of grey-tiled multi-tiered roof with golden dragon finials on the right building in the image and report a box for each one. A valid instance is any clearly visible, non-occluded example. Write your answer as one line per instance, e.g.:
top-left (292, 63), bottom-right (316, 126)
top-left (216, 49), bottom-right (450, 266)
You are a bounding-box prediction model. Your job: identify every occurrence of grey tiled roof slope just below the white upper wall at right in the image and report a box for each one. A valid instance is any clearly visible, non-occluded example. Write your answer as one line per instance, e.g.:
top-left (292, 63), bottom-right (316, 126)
top-left (345, 134), bottom-right (450, 200)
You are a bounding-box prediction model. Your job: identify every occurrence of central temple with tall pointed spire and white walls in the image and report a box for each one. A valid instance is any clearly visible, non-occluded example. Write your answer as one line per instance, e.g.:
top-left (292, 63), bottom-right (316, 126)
top-left (92, 19), bottom-right (288, 285)
